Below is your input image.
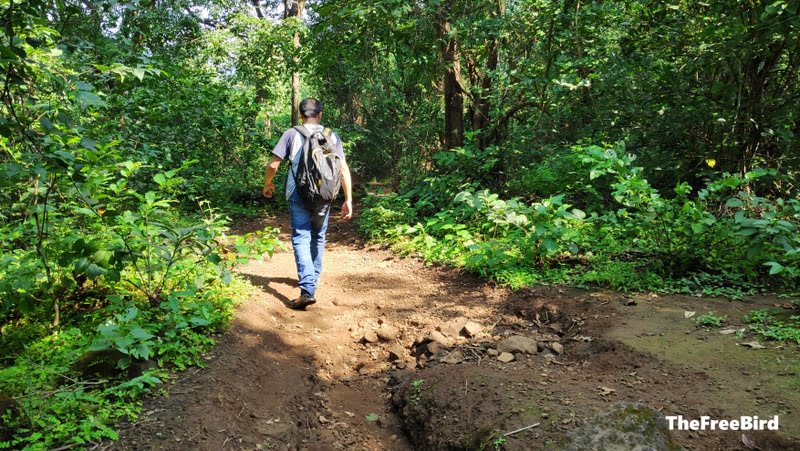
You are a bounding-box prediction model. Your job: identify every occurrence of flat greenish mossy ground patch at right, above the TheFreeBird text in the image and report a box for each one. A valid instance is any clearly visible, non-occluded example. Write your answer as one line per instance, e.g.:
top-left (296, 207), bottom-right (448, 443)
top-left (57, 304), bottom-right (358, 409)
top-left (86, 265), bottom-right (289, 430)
top-left (608, 297), bottom-right (800, 442)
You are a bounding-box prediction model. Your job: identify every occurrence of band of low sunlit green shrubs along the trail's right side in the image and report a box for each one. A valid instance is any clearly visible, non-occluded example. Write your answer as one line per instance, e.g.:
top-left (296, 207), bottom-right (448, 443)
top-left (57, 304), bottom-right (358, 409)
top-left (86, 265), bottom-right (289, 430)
top-left (359, 145), bottom-right (800, 299)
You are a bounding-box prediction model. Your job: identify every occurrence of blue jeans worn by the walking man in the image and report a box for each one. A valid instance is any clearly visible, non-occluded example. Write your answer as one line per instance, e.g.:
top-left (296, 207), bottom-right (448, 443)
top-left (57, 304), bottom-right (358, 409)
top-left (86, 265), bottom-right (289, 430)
top-left (289, 190), bottom-right (331, 298)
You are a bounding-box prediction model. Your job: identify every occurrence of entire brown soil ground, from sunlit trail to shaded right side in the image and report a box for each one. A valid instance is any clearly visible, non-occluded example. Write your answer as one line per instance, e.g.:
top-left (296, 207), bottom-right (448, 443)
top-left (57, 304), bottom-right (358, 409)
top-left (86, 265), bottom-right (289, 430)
top-left (113, 216), bottom-right (800, 450)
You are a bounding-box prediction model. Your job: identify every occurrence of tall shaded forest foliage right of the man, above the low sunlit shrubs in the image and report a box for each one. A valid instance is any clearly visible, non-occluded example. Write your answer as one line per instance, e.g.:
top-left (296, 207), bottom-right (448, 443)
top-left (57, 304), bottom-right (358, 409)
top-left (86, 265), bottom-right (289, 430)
top-left (312, 0), bottom-right (800, 190)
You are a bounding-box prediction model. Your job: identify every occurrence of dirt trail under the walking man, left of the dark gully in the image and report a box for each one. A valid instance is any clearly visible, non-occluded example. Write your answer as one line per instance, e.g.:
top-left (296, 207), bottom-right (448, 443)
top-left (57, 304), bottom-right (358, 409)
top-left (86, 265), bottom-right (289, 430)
top-left (115, 217), bottom-right (462, 450)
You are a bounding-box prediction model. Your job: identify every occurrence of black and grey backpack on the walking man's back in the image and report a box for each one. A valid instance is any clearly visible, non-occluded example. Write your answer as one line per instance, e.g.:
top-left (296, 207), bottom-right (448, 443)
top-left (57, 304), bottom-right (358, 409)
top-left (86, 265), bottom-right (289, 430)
top-left (292, 125), bottom-right (342, 208)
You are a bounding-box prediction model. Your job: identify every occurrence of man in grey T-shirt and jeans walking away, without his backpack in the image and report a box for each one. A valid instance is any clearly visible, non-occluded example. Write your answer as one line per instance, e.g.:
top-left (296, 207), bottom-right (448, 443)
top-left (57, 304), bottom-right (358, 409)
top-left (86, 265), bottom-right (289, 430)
top-left (263, 98), bottom-right (353, 310)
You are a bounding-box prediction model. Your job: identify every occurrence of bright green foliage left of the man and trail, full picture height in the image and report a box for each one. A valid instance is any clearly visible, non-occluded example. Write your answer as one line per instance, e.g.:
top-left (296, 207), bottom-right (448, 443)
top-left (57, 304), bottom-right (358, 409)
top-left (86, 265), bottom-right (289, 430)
top-left (0, 1), bottom-right (290, 449)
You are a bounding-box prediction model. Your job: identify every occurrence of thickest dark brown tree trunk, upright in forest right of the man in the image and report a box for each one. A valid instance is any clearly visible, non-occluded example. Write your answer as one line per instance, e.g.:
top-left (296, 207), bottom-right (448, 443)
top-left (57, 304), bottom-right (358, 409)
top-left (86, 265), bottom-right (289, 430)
top-left (439, 4), bottom-right (464, 149)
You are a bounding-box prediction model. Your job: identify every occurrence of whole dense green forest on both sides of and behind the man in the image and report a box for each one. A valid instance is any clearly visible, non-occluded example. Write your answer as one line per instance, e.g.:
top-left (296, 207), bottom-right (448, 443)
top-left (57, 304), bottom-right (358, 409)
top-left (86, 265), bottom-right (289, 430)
top-left (0, 0), bottom-right (800, 448)
